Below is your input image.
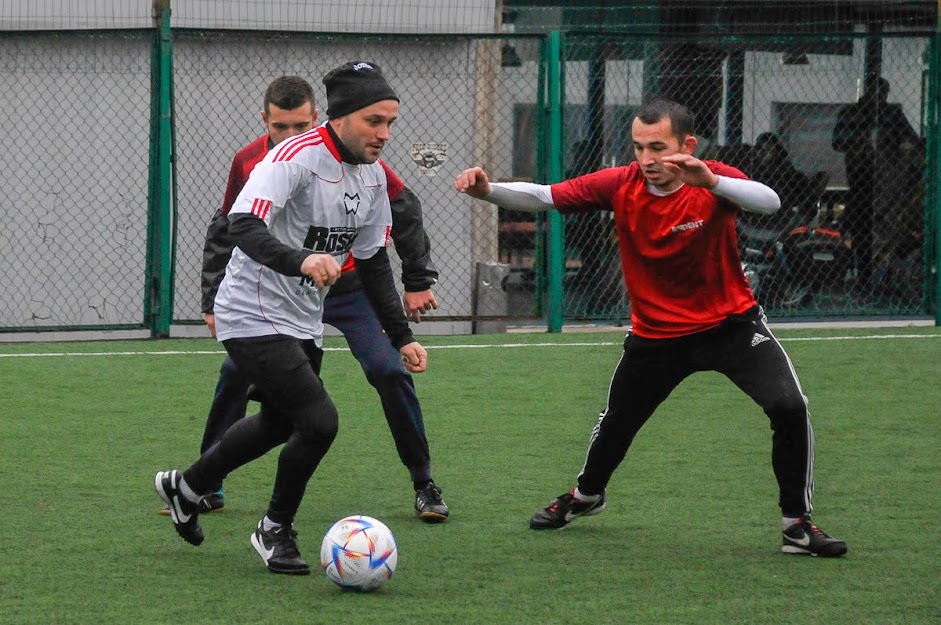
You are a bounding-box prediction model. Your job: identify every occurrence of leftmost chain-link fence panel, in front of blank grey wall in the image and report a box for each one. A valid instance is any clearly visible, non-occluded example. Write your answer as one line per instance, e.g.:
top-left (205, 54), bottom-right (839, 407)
top-left (0, 31), bottom-right (153, 331)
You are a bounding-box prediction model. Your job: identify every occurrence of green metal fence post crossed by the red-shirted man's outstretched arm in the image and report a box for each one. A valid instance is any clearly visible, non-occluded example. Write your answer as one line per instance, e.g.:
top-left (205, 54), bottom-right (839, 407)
top-left (546, 31), bottom-right (565, 332)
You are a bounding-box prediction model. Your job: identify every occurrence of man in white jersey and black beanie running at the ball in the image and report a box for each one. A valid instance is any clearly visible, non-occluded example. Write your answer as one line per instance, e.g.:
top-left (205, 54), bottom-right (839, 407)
top-left (154, 62), bottom-right (427, 575)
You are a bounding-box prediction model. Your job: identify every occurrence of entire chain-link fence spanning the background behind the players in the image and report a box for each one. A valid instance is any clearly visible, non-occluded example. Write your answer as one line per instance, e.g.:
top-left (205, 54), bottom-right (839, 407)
top-left (0, 3), bottom-right (937, 332)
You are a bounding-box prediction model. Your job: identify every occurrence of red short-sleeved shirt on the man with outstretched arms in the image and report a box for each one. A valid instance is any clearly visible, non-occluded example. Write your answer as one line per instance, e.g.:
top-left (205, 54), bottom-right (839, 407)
top-left (551, 161), bottom-right (756, 339)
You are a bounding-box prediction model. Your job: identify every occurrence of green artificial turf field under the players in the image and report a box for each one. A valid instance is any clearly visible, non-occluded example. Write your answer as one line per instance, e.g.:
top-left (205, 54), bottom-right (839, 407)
top-left (0, 328), bottom-right (941, 625)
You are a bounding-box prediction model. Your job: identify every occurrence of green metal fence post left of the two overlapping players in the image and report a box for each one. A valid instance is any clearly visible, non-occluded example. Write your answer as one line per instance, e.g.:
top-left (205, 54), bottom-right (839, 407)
top-left (144, 0), bottom-right (175, 337)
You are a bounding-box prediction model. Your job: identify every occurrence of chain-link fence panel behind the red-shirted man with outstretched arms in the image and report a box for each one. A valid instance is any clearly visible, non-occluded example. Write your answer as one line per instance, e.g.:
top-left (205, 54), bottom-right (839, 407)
top-left (565, 35), bottom-right (933, 320)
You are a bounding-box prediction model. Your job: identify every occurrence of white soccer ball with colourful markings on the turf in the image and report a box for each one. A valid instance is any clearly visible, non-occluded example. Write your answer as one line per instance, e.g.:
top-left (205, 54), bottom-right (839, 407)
top-left (320, 516), bottom-right (399, 592)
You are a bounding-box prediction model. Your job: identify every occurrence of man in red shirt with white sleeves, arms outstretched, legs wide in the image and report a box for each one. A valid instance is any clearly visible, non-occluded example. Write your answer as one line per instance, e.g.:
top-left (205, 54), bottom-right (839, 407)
top-left (454, 99), bottom-right (847, 556)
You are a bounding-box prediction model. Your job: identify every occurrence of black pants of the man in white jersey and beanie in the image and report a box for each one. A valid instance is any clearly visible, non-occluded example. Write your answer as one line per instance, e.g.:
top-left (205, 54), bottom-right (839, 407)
top-left (184, 335), bottom-right (339, 523)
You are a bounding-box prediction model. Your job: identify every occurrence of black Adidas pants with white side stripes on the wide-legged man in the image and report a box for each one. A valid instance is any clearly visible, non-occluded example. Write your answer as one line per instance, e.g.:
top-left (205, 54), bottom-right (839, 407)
top-left (578, 308), bottom-right (814, 517)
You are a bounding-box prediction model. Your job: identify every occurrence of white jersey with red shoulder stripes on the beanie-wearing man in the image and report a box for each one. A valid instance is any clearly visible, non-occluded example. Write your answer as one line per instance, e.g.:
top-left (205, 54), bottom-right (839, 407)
top-left (214, 126), bottom-right (392, 345)
